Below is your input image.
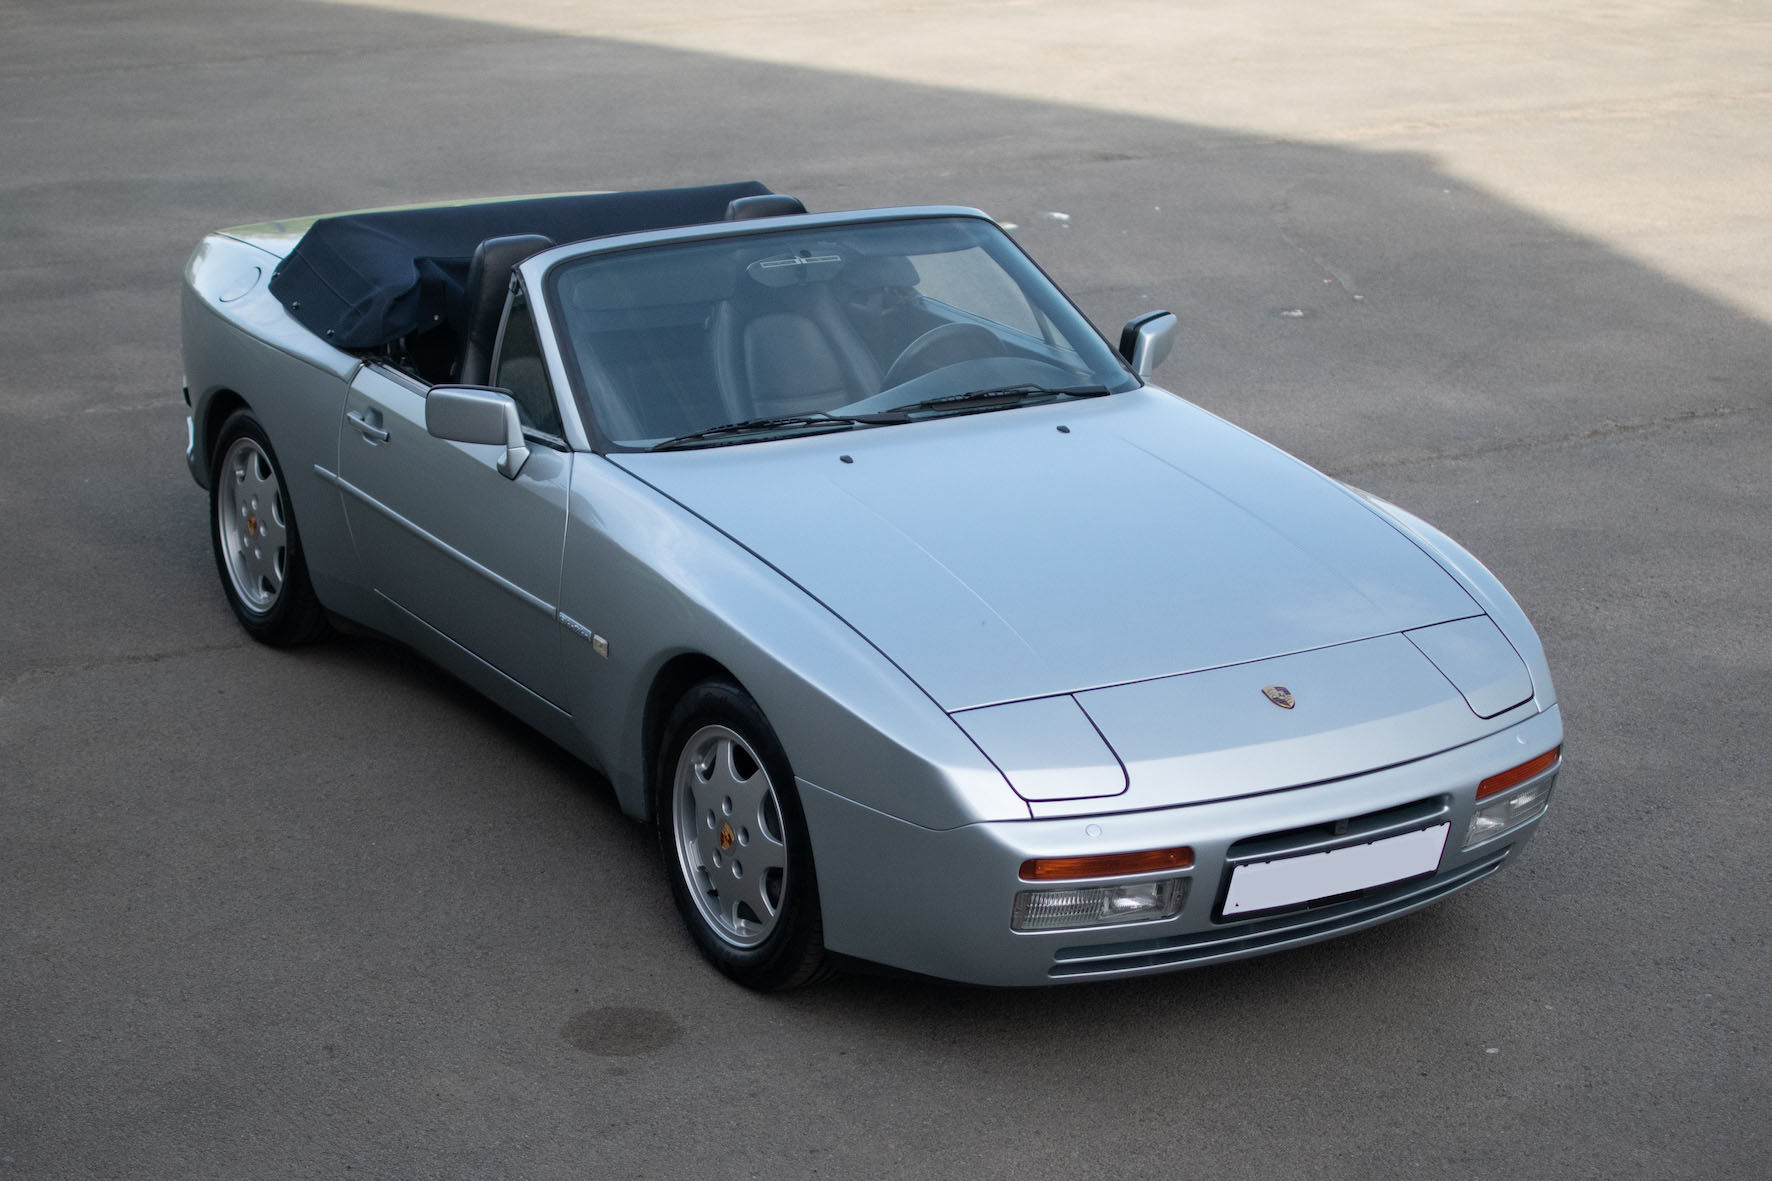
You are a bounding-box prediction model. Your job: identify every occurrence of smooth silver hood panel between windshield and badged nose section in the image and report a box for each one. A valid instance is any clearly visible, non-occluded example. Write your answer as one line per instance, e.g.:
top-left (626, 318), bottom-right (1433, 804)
top-left (610, 387), bottom-right (1481, 711)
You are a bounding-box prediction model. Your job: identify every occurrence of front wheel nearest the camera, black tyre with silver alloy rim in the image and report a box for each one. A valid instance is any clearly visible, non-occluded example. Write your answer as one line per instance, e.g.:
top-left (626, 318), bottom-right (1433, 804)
top-left (654, 681), bottom-right (829, 991)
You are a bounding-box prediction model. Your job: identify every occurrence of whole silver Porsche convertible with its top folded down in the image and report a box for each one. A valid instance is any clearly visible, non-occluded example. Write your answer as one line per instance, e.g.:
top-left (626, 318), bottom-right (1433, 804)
top-left (183, 183), bottom-right (1563, 989)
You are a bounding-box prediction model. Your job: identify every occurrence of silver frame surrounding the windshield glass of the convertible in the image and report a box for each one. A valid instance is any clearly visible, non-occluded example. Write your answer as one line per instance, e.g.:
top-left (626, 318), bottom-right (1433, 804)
top-left (517, 206), bottom-right (1143, 454)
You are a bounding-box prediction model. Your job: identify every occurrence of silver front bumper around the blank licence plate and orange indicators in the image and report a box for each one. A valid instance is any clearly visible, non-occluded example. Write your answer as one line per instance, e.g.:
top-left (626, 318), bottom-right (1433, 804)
top-left (799, 706), bottom-right (1563, 986)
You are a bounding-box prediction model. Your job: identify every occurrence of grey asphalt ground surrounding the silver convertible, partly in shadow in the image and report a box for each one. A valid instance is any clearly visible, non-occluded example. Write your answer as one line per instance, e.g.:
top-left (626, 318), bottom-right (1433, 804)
top-left (0, 0), bottom-right (1772, 1179)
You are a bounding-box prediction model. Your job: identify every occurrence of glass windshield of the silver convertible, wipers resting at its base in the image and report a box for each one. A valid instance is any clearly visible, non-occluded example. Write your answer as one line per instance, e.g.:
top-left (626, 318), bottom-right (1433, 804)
top-left (548, 216), bottom-right (1138, 449)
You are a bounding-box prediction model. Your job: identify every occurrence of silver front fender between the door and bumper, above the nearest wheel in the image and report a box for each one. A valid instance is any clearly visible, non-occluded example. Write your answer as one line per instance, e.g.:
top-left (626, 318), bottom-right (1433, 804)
top-left (560, 456), bottom-right (1030, 828)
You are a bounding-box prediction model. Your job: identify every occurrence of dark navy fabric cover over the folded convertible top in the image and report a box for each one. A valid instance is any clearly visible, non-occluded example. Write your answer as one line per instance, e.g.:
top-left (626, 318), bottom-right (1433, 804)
top-left (271, 181), bottom-right (769, 349)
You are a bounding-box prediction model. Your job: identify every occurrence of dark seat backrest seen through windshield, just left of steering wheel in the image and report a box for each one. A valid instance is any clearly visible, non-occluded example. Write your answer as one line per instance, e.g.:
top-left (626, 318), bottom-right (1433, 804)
top-left (709, 284), bottom-right (881, 422)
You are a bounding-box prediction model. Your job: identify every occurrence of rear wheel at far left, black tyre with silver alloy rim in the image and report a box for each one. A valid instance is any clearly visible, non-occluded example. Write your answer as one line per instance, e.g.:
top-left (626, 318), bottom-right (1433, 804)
top-left (209, 410), bottom-right (326, 647)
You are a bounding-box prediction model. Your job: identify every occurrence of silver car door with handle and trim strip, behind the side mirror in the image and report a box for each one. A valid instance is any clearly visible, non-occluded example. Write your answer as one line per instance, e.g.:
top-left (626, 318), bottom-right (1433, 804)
top-left (338, 293), bottom-right (572, 709)
